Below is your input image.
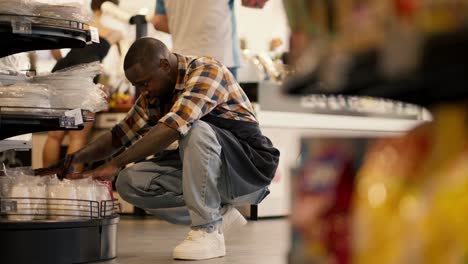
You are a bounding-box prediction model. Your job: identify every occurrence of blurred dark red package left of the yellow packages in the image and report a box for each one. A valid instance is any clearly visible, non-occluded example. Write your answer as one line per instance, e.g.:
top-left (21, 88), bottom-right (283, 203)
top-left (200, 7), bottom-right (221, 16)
top-left (291, 138), bottom-right (367, 263)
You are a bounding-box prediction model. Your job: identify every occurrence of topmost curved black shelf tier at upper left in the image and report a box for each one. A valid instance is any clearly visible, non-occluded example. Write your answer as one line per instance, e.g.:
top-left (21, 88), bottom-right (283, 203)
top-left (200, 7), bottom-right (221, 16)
top-left (0, 14), bottom-right (91, 57)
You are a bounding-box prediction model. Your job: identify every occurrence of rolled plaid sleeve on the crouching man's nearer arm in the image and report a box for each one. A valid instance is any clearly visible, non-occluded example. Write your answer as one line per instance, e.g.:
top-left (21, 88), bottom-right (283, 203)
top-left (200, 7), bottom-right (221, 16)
top-left (159, 64), bottom-right (228, 136)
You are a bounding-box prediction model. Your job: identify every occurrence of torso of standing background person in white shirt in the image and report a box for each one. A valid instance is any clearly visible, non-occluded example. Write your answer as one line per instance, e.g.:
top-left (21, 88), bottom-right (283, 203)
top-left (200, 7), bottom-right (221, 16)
top-left (153, 0), bottom-right (240, 78)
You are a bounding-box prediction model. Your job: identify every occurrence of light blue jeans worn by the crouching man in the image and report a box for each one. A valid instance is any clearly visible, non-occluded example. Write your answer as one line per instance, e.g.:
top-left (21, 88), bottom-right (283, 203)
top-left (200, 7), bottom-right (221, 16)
top-left (116, 120), bottom-right (268, 228)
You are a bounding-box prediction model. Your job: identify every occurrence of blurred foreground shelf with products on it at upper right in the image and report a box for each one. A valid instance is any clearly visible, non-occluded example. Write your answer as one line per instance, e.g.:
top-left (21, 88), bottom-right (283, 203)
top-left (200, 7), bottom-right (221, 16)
top-left (284, 0), bottom-right (468, 106)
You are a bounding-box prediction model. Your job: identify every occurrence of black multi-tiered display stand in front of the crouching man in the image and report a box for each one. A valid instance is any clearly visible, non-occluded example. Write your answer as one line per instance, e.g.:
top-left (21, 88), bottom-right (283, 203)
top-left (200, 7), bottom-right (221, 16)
top-left (0, 10), bottom-right (120, 264)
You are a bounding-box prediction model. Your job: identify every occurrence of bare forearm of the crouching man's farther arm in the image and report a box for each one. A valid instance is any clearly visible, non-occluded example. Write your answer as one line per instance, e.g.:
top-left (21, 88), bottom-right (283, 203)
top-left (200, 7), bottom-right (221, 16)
top-left (73, 131), bottom-right (119, 163)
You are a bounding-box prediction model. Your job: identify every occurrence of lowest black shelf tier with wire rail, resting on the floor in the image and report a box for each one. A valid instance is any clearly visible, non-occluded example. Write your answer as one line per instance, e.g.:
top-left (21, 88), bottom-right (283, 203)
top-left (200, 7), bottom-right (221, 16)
top-left (0, 198), bottom-right (120, 264)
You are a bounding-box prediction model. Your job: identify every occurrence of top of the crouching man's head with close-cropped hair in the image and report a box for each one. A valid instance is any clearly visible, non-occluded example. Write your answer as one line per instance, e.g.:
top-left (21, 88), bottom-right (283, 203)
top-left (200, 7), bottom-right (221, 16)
top-left (124, 38), bottom-right (171, 70)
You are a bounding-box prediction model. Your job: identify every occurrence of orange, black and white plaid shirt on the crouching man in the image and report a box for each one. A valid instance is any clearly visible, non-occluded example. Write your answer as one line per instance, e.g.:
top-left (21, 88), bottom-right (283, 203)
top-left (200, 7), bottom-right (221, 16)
top-left (113, 54), bottom-right (257, 145)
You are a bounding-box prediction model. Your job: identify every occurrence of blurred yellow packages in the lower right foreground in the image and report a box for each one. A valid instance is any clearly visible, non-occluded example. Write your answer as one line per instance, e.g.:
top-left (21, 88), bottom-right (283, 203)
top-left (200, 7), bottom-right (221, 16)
top-left (353, 104), bottom-right (468, 264)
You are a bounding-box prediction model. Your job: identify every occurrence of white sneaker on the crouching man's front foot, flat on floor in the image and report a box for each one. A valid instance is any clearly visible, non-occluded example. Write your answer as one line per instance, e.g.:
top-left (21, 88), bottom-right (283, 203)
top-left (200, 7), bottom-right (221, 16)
top-left (172, 230), bottom-right (226, 260)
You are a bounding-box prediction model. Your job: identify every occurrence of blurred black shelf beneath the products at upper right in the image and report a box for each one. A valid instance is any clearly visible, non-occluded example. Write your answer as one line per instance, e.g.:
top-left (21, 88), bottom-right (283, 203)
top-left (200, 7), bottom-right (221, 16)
top-left (284, 29), bottom-right (468, 106)
